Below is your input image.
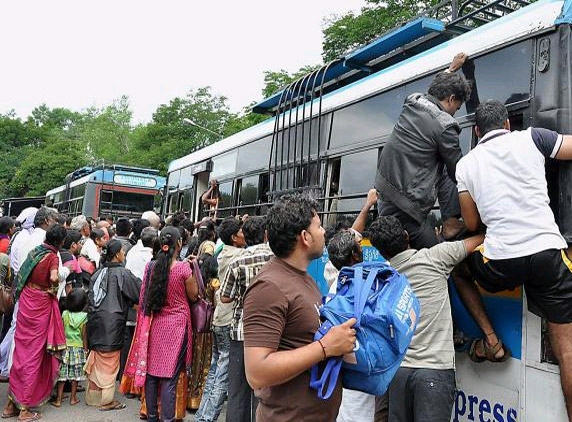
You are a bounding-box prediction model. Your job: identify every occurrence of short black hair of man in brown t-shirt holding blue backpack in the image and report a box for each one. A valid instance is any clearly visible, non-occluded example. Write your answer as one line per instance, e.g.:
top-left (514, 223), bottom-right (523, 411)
top-left (266, 194), bottom-right (318, 258)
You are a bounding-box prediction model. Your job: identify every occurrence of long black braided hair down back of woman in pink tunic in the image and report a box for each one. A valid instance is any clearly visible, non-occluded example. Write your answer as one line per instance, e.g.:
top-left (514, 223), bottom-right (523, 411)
top-left (145, 226), bottom-right (181, 315)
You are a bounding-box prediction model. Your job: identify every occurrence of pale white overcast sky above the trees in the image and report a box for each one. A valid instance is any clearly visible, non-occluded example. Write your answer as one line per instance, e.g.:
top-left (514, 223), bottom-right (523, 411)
top-left (0, 0), bottom-right (365, 123)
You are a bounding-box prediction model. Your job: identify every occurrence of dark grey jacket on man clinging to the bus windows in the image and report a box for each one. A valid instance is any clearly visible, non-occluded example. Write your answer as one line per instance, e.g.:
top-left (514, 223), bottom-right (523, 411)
top-left (375, 93), bottom-right (463, 223)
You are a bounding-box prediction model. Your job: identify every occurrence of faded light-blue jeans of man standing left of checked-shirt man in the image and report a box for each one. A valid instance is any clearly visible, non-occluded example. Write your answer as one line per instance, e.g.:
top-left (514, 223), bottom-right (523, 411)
top-left (195, 325), bottom-right (230, 422)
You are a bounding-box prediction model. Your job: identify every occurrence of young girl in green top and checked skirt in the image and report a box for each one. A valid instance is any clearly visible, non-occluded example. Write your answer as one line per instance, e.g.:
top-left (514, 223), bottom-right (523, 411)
top-left (52, 288), bottom-right (87, 407)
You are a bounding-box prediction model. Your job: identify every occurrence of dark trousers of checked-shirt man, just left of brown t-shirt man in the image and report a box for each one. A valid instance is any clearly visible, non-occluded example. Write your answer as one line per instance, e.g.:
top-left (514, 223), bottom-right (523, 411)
top-left (226, 340), bottom-right (258, 422)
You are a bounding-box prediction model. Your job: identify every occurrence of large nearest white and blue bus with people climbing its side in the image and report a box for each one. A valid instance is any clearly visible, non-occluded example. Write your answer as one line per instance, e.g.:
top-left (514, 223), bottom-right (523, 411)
top-left (168, 0), bottom-right (572, 422)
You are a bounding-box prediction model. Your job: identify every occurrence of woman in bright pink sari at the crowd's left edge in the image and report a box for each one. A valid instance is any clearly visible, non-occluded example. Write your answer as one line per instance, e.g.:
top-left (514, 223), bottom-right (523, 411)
top-left (2, 224), bottom-right (66, 421)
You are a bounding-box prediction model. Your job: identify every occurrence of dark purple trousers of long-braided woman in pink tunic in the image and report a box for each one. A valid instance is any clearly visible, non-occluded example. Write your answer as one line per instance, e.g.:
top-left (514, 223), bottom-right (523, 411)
top-left (145, 336), bottom-right (187, 422)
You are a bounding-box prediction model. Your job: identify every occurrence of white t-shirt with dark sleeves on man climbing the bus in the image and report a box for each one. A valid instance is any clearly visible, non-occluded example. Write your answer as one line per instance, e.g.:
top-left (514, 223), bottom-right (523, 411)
top-left (456, 128), bottom-right (567, 259)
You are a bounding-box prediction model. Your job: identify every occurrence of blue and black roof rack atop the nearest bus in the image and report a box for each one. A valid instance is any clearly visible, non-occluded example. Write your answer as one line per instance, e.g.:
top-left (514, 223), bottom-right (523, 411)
top-left (252, 0), bottom-right (530, 115)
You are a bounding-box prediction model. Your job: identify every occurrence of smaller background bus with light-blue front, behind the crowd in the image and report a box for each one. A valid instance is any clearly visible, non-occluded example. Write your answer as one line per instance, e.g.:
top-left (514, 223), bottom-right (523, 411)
top-left (46, 164), bottom-right (166, 218)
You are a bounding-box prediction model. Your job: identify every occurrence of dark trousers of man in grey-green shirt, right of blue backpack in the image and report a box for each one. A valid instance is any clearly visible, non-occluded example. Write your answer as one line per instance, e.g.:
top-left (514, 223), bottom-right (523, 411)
top-left (389, 368), bottom-right (455, 422)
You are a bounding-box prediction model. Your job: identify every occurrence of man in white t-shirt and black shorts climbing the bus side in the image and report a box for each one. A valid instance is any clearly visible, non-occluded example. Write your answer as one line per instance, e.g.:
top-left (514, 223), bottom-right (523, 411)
top-left (457, 101), bottom-right (572, 417)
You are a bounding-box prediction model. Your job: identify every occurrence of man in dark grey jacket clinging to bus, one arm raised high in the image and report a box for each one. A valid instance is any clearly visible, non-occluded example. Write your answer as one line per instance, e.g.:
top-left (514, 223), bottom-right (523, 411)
top-left (375, 53), bottom-right (470, 248)
